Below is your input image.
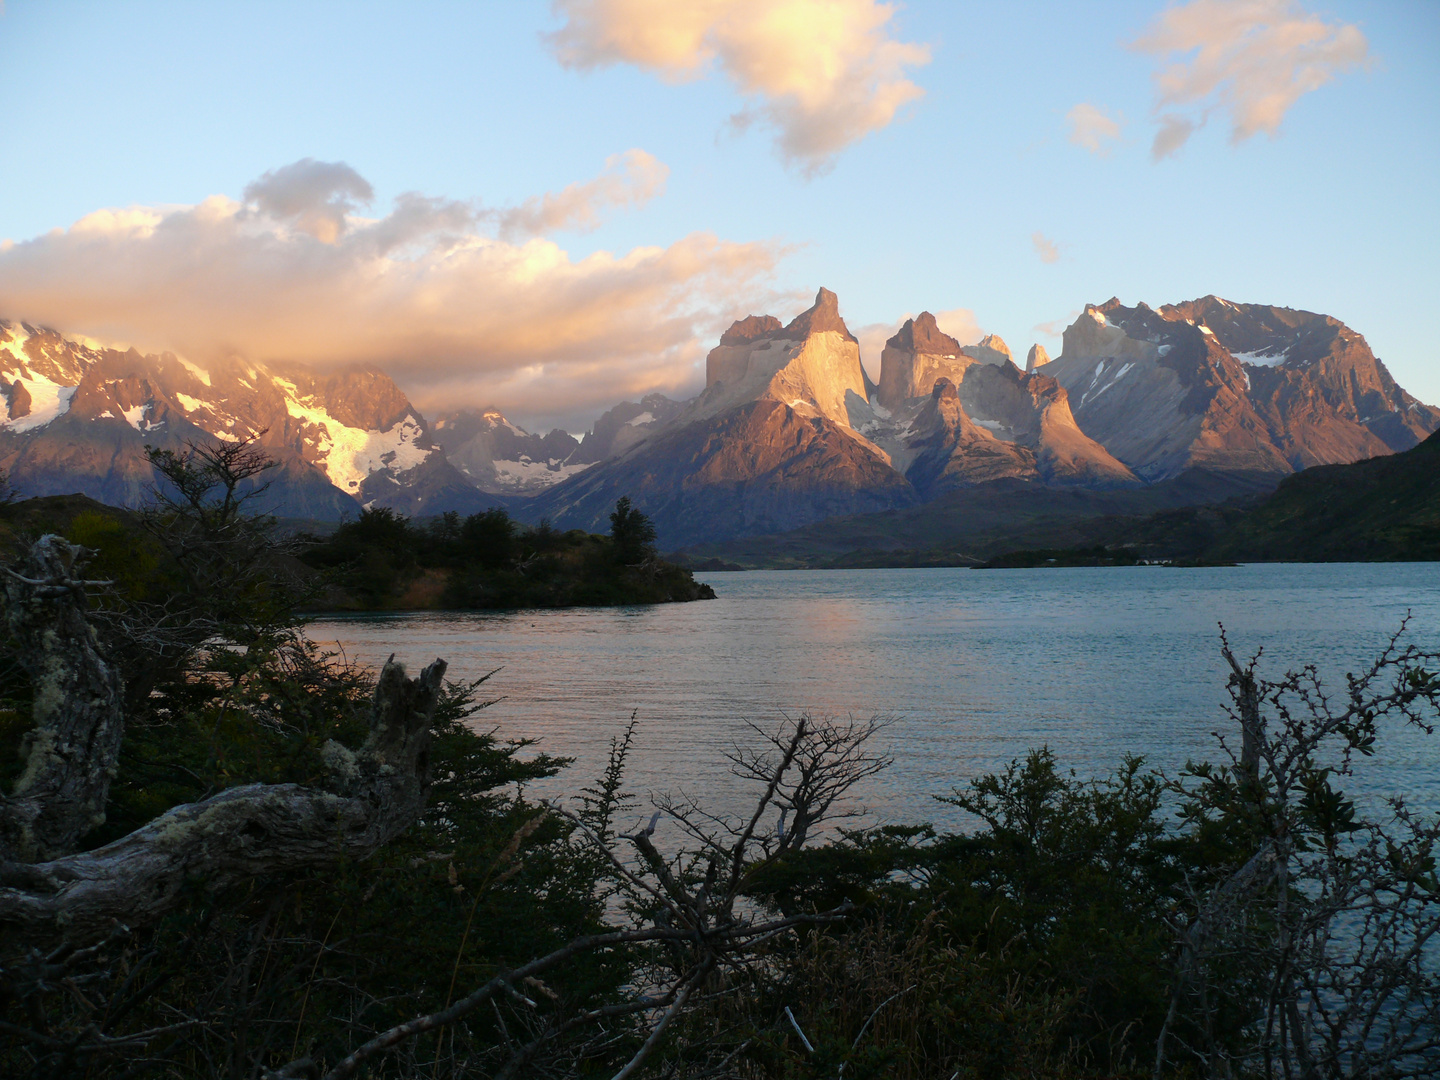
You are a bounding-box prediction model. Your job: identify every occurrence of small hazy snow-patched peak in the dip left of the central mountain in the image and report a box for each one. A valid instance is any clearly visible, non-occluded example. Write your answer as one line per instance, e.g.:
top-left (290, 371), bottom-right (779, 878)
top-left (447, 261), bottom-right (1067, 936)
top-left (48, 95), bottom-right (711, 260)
top-left (432, 406), bottom-right (586, 495)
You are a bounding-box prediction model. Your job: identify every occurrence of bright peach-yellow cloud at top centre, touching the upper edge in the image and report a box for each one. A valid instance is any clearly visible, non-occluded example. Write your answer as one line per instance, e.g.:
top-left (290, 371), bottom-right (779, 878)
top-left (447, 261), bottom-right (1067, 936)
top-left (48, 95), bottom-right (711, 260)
top-left (546, 0), bottom-right (930, 176)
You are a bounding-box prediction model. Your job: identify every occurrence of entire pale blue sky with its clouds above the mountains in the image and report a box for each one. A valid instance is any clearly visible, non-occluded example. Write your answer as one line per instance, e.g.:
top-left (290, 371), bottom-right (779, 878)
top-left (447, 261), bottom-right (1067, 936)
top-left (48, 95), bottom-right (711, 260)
top-left (0, 0), bottom-right (1440, 432)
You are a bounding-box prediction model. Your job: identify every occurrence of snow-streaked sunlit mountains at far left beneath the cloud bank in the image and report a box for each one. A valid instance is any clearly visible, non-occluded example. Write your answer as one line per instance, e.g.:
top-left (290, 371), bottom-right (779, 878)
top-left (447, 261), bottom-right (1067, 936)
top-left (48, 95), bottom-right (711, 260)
top-left (0, 321), bottom-right (481, 518)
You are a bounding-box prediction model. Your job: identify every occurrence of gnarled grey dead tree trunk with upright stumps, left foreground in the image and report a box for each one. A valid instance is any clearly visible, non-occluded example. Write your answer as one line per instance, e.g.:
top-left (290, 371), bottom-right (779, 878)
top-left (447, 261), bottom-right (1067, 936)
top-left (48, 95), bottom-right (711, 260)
top-left (0, 536), bottom-right (445, 940)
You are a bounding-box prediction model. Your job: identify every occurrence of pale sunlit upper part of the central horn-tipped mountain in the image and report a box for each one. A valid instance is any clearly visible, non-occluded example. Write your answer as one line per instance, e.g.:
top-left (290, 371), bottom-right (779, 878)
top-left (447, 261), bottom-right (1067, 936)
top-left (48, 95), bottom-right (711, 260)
top-left (690, 288), bottom-right (871, 428)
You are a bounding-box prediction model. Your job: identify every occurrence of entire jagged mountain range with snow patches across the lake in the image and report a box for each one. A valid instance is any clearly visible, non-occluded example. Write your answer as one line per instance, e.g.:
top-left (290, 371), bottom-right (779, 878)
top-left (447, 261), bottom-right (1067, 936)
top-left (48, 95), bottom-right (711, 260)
top-left (0, 289), bottom-right (1440, 549)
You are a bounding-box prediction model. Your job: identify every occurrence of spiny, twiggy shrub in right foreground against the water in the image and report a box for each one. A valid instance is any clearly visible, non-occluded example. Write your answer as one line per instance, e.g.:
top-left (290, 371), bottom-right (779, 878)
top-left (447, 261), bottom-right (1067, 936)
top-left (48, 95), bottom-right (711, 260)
top-left (1155, 625), bottom-right (1440, 1080)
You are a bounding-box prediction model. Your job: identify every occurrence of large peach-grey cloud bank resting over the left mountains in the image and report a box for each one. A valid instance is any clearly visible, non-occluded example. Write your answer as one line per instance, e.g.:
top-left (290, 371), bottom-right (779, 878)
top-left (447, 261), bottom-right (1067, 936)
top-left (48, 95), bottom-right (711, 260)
top-left (0, 158), bottom-right (786, 428)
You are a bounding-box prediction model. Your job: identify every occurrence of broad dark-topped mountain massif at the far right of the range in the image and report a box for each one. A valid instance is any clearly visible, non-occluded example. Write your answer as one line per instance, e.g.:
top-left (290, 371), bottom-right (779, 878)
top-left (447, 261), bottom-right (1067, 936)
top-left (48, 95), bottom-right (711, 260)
top-left (1037, 297), bottom-right (1440, 481)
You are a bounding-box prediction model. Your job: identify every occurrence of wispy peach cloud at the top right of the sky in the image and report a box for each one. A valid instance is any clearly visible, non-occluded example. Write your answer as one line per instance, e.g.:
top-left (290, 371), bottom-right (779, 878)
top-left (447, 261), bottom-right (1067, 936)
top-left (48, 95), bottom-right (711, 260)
top-left (1130, 0), bottom-right (1369, 161)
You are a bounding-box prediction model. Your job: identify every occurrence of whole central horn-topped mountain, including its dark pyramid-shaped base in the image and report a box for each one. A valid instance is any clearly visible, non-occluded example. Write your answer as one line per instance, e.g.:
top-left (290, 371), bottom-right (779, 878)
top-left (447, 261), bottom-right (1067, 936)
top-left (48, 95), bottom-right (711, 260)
top-left (523, 288), bottom-right (917, 546)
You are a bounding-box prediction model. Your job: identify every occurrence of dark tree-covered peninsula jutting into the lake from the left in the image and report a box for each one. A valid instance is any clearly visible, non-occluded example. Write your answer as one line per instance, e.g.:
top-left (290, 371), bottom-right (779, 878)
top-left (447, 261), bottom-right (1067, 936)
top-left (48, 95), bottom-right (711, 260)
top-left (301, 498), bottom-right (711, 609)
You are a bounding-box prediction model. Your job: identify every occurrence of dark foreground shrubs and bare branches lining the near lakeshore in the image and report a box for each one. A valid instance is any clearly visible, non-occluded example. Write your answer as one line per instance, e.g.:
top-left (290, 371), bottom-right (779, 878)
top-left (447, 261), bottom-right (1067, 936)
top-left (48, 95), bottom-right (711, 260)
top-left (0, 434), bottom-right (1440, 1080)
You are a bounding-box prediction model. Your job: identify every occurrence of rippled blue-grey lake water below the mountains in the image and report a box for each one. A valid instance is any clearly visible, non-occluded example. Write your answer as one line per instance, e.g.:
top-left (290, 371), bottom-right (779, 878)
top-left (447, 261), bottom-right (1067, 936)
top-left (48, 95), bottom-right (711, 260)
top-left (310, 563), bottom-right (1440, 822)
